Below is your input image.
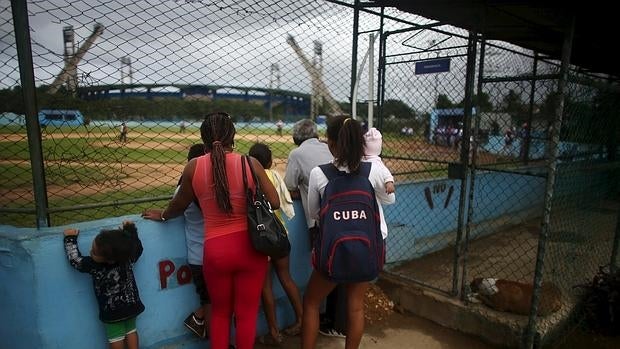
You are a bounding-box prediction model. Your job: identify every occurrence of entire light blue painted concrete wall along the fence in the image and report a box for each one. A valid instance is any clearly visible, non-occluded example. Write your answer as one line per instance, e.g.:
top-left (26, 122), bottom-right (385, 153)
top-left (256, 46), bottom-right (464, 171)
top-left (0, 163), bottom-right (614, 349)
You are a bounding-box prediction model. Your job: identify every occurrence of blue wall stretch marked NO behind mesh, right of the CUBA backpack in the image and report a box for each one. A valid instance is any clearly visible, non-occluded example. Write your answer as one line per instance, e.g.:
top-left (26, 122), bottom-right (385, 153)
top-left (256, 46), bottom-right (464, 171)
top-left (384, 172), bottom-right (545, 263)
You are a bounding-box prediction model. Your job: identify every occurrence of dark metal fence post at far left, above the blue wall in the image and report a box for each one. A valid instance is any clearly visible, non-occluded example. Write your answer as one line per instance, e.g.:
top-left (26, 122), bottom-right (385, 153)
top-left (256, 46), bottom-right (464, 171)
top-left (11, 0), bottom-right (50, 228)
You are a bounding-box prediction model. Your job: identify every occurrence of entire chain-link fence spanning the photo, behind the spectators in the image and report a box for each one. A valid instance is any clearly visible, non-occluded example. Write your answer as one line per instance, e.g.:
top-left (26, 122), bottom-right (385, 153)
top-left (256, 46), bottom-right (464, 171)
top-left (0, 0), bottom-right (620, 346)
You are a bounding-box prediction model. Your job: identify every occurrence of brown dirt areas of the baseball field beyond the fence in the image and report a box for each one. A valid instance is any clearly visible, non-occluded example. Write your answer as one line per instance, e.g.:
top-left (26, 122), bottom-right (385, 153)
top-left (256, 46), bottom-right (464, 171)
top-left (0, 130), bottom-right (484, 202)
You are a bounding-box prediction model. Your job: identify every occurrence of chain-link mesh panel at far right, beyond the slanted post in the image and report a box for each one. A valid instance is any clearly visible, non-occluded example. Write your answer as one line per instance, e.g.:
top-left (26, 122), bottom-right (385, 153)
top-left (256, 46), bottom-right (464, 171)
top-left (537, 74), bottom-right (620, 342)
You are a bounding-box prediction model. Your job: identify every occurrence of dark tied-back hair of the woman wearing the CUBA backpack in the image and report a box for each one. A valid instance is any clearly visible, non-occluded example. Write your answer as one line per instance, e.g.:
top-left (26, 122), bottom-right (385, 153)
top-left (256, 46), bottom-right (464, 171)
top-left (327, 115), bottom-right (365, 172)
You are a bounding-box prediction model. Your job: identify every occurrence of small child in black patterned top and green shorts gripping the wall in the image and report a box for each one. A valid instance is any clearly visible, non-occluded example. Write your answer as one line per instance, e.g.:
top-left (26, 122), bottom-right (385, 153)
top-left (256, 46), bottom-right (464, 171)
top-left (64, 221), bottom-right (144, 349)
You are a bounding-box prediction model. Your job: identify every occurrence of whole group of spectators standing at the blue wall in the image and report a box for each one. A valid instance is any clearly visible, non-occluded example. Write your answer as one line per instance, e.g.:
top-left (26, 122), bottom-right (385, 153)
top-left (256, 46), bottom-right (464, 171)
top-left (64, 112), bottom-right (395, 349)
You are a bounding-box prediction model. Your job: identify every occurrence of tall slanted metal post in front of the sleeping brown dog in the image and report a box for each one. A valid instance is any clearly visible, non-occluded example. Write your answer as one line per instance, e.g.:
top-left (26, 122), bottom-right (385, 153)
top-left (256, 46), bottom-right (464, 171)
top-left (522, 16), bottom-right (575, 349)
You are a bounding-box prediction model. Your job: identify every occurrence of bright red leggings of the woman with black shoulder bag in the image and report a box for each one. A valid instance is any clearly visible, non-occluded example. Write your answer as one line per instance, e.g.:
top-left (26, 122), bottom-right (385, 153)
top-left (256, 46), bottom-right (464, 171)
top-left (202, 231), bottom-right (268, 349)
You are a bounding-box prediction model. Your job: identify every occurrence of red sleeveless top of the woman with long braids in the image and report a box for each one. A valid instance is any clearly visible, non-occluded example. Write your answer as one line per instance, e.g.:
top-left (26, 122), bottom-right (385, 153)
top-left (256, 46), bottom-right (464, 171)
top-left (192, 153), bottom-right (254, 240)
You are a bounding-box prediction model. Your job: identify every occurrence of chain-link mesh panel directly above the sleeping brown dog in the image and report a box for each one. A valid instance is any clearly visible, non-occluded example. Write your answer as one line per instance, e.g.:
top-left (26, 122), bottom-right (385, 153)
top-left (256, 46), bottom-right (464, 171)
top-left (464, 51), bottom-right (559, 290)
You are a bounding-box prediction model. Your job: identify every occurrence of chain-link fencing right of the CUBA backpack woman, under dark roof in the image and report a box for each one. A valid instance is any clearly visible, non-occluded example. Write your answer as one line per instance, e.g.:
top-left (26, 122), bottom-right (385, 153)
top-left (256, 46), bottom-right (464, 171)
top-left (352, 3), bottom-right (619, 341)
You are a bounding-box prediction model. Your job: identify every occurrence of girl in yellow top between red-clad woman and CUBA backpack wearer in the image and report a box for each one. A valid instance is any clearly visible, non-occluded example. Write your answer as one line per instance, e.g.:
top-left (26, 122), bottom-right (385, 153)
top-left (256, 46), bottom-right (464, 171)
top-left (249, 143), bottom-right (302, 345)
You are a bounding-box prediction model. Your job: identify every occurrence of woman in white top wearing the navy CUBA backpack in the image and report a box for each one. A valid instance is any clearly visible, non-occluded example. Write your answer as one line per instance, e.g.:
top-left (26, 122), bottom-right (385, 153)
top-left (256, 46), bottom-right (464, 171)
top-left (302, 116), bottom-right (395, 349)
